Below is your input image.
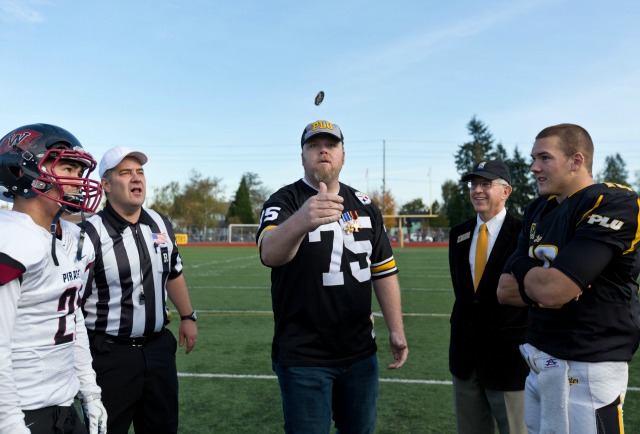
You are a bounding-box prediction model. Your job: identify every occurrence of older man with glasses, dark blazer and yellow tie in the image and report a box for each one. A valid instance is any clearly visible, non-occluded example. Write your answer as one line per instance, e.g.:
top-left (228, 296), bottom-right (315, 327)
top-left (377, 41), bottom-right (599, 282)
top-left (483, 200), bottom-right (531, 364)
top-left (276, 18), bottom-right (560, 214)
top-left (449, 160), bottom-right (529, 434)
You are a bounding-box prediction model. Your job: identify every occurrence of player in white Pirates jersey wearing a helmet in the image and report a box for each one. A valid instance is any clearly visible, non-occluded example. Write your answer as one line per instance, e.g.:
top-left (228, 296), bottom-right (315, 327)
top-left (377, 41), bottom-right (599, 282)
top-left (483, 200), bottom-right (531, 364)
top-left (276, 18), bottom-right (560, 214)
top-left (0, 124), bottom-right (107, 434)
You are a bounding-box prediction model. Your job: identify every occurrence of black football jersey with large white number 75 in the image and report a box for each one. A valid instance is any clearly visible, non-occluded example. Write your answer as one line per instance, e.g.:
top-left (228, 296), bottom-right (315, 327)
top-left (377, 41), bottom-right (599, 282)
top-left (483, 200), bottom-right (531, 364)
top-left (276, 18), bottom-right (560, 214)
top-left (256, 180), bottom-right (398, 366)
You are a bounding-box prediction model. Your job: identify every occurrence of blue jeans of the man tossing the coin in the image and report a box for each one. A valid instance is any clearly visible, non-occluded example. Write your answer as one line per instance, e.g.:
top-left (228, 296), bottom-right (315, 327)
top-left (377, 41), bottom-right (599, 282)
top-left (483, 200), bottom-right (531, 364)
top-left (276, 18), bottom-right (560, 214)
top-left (273, 354), bottom-right (378, 434)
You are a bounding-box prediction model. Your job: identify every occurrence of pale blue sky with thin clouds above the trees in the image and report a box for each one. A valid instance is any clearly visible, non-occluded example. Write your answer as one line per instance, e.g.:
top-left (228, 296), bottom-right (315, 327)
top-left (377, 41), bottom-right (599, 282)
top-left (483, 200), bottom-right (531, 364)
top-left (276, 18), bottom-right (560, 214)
top-left (0, 0), bottom-right (640, 205)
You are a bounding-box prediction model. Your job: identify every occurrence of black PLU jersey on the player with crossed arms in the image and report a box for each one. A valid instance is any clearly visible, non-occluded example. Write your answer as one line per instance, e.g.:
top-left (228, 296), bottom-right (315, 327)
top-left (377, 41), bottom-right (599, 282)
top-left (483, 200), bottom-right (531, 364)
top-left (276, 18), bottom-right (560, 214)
top-left (514, 183), bottom-right (640, 362)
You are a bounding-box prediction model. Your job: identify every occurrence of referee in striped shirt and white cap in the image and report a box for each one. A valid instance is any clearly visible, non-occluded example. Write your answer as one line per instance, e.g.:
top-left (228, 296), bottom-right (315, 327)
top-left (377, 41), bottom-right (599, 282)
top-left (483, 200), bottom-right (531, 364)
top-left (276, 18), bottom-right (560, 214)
top-left (82, 146), bottom-right (198, 434)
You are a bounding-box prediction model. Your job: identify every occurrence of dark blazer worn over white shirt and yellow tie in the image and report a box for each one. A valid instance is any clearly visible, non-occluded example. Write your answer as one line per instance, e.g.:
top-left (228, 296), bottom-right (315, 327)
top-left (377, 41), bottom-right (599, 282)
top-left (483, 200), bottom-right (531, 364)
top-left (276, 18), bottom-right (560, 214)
top-left (449, 212), bottom-right (529, 391)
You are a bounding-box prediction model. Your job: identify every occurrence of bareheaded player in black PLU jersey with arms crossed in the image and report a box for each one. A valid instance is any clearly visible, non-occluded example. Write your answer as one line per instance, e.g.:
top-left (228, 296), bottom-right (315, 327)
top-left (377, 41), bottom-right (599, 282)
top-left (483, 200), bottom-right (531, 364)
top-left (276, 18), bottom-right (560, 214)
top-left (498, 124), bottom-right (640, 434)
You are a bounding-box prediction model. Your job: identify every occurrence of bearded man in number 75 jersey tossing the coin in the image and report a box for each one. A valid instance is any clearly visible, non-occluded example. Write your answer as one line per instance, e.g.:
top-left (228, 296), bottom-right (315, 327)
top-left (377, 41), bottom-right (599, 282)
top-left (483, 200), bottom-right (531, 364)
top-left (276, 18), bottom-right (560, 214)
top-left (257, 121), bottom-right (408, 434)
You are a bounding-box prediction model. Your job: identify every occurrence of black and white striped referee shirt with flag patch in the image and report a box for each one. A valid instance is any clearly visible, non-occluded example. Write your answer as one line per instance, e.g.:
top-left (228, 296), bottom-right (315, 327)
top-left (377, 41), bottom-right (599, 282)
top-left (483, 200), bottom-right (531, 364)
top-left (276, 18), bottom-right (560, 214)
top-left (82, 201), bottom-right (182, 337)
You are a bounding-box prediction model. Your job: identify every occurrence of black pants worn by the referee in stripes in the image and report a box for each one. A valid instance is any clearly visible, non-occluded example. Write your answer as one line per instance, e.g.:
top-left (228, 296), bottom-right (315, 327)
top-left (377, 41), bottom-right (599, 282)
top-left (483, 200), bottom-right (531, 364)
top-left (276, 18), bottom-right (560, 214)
top-left (89, 328), bottom-right (178, 434)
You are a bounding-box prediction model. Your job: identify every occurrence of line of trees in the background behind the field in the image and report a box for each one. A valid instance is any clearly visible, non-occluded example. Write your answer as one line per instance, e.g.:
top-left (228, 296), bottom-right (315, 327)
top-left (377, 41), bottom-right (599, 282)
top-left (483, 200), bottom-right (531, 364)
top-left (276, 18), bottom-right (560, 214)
top-left (150, 116), bottom-right (640, 229)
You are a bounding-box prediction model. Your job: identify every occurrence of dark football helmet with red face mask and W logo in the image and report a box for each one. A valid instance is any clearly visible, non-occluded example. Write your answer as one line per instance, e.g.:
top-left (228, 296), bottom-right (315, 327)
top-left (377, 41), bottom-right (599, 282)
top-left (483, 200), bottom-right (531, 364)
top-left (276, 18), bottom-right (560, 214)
top-left (0, 124), bottom-right (102, 212)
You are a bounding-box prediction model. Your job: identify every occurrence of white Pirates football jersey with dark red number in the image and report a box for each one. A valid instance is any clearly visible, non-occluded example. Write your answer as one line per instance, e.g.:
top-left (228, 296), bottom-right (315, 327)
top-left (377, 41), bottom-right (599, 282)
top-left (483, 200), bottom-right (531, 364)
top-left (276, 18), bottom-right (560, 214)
top-left (0, 210), bottom-right (100, 433)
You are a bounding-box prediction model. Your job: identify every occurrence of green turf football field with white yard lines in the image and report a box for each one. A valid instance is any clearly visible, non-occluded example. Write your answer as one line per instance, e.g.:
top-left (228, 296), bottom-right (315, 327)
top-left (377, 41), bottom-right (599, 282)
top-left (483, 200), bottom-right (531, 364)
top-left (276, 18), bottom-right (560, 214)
top-left (169, 247), bottom-right (640, 434)
